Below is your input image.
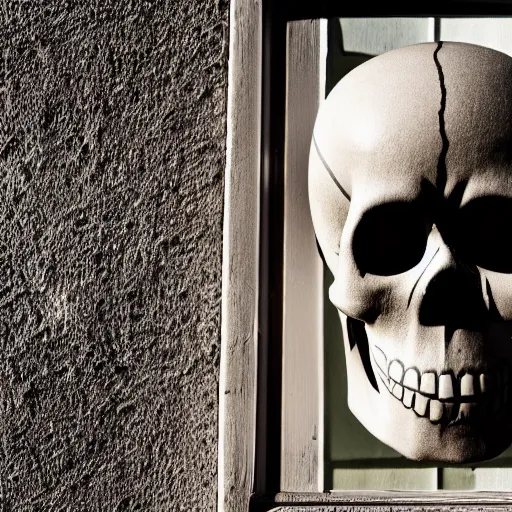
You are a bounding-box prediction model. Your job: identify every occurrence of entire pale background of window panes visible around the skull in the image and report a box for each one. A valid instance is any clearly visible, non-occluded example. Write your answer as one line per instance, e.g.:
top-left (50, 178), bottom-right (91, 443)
top-left (324, 14), bottom-right (512, 490)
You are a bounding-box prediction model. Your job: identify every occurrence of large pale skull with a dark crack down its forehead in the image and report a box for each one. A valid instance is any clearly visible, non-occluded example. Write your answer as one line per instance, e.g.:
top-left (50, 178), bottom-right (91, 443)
top-left (309, 42), bottom-right (512, 463)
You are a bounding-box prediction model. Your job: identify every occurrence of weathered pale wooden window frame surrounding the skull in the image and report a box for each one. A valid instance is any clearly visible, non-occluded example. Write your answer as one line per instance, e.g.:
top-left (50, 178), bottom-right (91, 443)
top-left (218, 0), bottom-right (512, 512)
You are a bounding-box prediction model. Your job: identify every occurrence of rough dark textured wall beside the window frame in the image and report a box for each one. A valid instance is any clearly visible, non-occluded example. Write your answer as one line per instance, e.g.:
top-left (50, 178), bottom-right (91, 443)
top-left (0, 0), bottom-right (228, 511)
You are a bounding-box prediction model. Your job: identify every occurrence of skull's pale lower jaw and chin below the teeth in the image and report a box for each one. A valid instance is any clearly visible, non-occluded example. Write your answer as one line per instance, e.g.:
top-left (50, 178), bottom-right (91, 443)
top-left (340, 313), bottom-right (512, 464)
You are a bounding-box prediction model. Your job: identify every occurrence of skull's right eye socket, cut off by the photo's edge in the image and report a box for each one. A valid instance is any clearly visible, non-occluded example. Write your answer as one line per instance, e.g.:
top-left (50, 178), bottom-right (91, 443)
top-left (456, 196), bottom-right (512, 274)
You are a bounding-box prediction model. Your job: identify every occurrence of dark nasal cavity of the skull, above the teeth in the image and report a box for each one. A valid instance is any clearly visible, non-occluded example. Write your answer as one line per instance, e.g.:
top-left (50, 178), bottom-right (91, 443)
top-left (419, 268), bottom-right (488, 330)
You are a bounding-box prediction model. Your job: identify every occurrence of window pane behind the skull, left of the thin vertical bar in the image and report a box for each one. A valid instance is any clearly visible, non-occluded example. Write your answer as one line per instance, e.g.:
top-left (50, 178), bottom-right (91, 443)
top-left (324, 18), bottom-right (438, 490)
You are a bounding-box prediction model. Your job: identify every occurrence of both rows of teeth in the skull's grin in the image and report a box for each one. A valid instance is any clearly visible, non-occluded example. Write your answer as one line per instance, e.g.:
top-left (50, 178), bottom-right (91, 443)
top-left (372, 347), bottom-right (508, 423)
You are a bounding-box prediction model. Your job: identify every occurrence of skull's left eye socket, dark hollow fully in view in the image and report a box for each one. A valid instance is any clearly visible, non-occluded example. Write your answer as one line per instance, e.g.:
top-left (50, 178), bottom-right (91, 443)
top-left (352, 202), bottom-right (432, 276)
